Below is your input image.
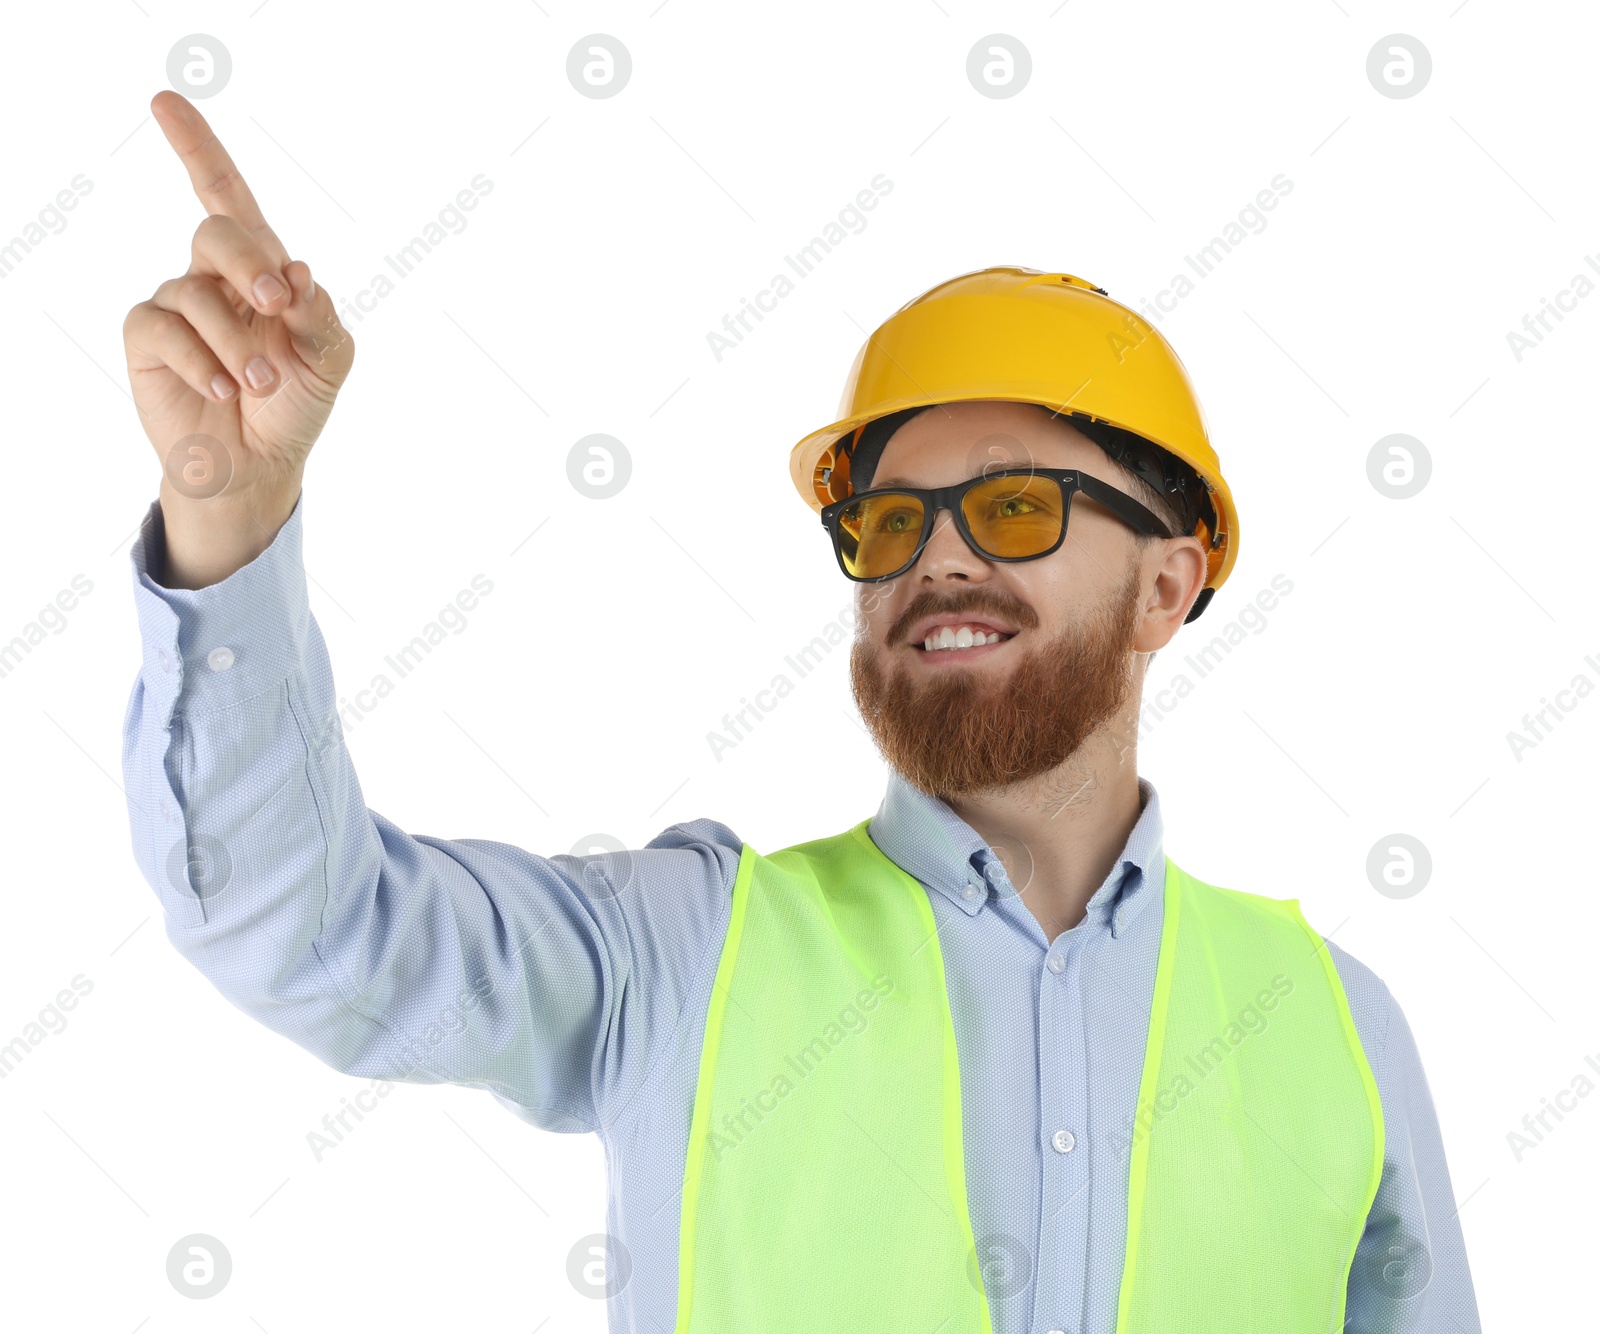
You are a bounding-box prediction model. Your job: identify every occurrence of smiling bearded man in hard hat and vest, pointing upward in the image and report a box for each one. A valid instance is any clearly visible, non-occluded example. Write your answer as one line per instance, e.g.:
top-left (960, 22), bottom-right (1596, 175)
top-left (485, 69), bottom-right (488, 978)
top-left (125, 93), bottom-right (1478, 1334)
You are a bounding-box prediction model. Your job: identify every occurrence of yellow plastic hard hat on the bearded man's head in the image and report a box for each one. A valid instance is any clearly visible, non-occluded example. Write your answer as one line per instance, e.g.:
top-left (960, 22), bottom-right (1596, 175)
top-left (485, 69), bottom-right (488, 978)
top-left (789, 267), bottom-right (1238, 621)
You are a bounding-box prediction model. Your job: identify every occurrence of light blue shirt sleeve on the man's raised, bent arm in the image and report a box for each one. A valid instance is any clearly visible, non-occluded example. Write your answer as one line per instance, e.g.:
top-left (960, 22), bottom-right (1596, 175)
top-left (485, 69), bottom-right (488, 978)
top-left (123, 496), bottom-right (742, 1132)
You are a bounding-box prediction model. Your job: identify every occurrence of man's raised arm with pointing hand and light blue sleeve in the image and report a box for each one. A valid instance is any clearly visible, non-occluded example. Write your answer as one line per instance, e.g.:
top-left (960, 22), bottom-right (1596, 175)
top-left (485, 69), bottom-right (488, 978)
top-left (123, 93), bottom-right (741, 1131)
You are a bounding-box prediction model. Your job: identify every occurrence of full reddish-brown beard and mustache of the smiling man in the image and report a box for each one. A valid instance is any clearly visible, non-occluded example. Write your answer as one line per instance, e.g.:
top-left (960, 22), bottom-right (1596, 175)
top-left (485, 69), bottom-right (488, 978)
top-left (850, 565), bottom-right (1139, 798)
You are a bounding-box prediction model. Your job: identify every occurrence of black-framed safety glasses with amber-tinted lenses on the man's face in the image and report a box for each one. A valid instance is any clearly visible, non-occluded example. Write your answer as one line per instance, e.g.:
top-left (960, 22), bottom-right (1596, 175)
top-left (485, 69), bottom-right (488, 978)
top-left (822, 467), bottom-right (1173, 584)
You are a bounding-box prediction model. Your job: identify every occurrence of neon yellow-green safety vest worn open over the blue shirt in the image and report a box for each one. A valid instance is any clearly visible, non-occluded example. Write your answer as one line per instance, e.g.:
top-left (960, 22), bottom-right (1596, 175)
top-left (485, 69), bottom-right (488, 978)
top-left (675, 821), bottom-right (1384, 1334)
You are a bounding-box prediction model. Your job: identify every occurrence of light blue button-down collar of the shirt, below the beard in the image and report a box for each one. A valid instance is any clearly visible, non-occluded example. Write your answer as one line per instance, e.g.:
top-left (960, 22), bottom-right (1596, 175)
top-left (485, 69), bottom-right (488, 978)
top-left (867, 758), bottom-right (1166, 936)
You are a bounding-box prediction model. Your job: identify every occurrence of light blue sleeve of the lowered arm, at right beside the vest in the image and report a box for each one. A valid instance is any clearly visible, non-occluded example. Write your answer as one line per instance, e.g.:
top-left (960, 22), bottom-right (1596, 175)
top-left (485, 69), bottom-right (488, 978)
top-left (1328, 942), bottom-right (1482, 1334)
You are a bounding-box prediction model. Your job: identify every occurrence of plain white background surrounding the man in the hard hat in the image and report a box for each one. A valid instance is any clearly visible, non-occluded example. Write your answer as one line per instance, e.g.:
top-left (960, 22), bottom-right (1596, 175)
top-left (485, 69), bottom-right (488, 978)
top-left (0, 0), bottom-right (1600, 1334)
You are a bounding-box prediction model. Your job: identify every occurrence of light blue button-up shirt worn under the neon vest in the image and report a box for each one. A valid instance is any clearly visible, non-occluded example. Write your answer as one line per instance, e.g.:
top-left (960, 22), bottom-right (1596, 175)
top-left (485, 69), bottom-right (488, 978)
top-left (123, 497), bottom-right (1480, 1334)
